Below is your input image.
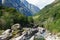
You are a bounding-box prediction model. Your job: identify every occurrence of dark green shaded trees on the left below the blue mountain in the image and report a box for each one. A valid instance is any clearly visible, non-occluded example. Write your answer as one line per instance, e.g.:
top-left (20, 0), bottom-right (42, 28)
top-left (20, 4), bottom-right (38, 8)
top-left (0, 6), bottom-right (31, 29)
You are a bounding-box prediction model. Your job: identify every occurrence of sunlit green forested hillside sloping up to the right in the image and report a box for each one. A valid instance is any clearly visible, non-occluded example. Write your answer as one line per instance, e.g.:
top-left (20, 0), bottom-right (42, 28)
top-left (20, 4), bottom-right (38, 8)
top-left (34, 0), bottom-right (60, 33)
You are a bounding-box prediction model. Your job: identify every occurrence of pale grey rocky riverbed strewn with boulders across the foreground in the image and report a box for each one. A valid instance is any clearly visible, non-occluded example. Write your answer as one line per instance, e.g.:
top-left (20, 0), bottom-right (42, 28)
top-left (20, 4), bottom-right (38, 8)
top-left (0, 24), bottom-right (60, 40)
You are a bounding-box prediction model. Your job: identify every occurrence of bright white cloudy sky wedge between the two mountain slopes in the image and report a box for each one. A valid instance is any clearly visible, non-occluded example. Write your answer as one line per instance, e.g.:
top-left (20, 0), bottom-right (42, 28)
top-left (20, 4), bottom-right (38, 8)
top-left (26, 0), bottom-right (55, 9)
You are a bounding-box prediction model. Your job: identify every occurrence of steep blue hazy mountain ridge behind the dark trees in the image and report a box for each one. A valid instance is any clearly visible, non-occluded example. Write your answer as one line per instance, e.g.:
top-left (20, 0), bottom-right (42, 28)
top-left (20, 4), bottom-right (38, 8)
top-left (3, 0), bottom-right (40, 16)
